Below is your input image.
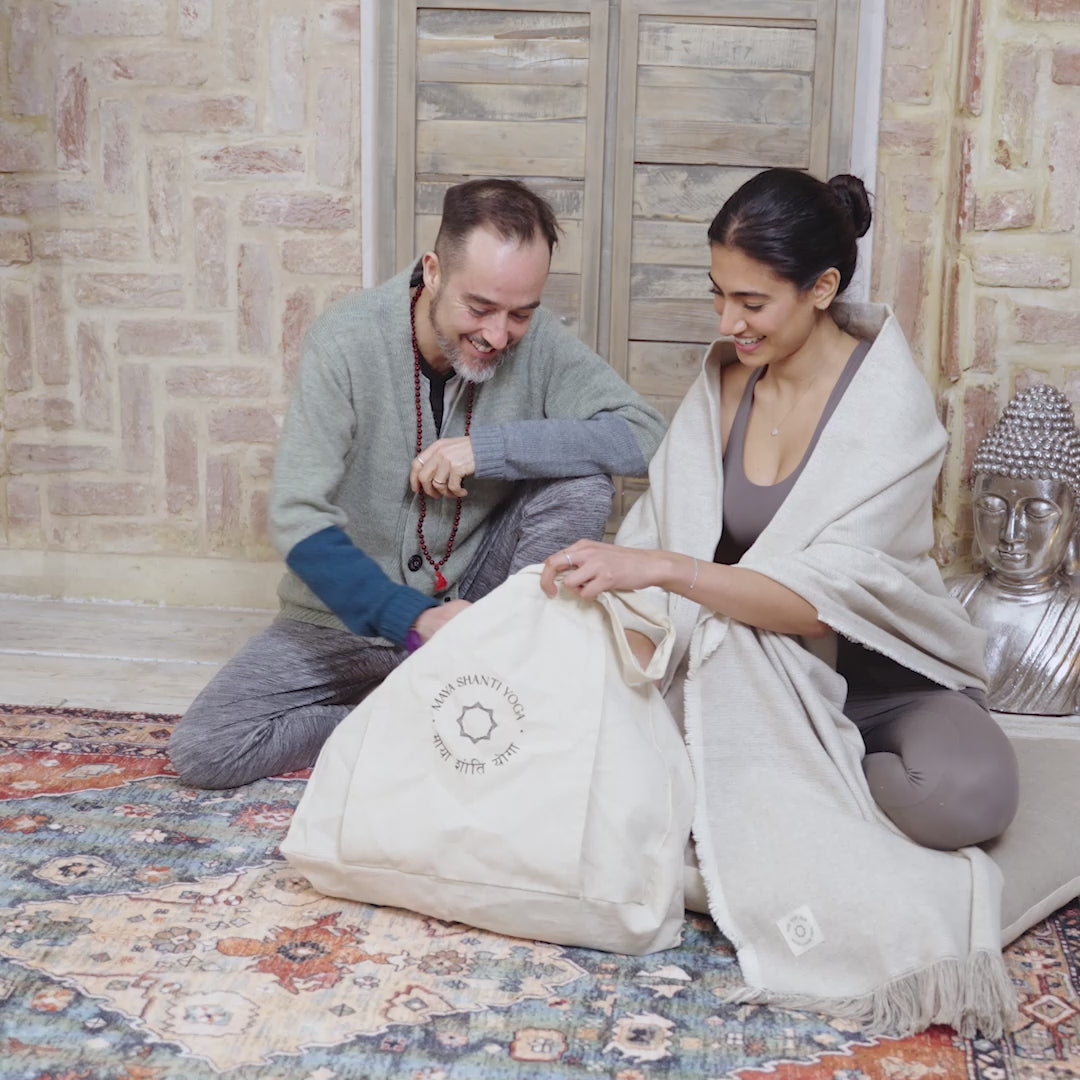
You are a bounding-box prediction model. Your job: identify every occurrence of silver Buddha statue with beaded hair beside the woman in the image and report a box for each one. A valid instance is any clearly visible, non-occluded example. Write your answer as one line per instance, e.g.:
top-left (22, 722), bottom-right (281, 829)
top-left (947, 386), bottom-right (1080, 716)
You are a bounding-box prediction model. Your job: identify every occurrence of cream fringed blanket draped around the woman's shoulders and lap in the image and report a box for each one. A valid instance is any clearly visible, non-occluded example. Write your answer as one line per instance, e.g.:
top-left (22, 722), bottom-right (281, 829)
top-left (617, 305), bottom-right (1013, 1037)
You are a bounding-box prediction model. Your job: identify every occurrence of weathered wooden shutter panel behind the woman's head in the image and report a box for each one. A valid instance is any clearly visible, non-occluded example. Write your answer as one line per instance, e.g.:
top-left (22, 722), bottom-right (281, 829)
top-left (608, 0), bottom-right (858, 512)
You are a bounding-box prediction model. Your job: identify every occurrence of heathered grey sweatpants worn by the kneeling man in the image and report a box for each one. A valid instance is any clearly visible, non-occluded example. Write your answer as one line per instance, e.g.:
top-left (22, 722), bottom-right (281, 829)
top-left (168, 476), bottom-right (615, 788)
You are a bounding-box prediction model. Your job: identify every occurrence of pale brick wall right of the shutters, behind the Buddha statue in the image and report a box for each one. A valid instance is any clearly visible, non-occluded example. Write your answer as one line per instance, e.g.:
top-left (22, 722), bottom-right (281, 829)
top-left (872, 0), bottom-right (1080, 564)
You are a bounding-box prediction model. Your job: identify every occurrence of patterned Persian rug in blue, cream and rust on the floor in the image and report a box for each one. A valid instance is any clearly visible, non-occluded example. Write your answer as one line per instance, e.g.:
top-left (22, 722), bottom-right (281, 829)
top-left (0, 706), bottom-right (1080, 1080)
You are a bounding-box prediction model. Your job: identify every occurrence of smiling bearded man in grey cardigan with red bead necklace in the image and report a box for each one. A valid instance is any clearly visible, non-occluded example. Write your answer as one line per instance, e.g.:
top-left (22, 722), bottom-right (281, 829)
top-left (170, 179), bottom-right (663, 787)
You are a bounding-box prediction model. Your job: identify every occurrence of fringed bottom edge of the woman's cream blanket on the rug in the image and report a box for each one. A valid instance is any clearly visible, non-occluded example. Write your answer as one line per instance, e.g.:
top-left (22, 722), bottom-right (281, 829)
top-left (724, 950), bottom-right (1018, 1039)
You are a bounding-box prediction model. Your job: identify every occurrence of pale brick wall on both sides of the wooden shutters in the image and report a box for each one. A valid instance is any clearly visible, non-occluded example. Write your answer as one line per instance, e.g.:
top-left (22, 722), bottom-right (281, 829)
top-left (0, 0), bottom-right (1080, 604)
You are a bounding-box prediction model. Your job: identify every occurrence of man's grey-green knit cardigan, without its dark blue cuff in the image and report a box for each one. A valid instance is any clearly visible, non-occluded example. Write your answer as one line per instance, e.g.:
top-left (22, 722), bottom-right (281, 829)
top-left (270, 269), bottom-right (664, 627)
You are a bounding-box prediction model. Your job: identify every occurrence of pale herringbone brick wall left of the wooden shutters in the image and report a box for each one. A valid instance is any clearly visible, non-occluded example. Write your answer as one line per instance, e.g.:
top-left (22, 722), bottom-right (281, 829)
top-left (0, 0), bottom-right (361, 604)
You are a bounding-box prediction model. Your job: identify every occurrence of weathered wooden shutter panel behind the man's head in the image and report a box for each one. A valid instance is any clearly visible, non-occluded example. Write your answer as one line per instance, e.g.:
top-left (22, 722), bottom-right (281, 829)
top-left (396, 0), bottom-right (608, 347)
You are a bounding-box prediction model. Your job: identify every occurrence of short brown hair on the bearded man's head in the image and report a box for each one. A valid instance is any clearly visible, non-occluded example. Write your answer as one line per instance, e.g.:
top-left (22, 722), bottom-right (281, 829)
top-left (435, 178), bottom-right (559, 265)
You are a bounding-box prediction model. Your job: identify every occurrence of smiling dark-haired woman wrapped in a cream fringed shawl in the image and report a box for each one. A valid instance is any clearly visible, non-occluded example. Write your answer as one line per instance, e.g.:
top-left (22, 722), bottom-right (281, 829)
top-left (542, 168), bottom-right (1017, 1031)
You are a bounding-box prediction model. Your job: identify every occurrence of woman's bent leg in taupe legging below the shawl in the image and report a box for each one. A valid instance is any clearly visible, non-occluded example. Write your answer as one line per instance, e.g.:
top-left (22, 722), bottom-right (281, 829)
top-left (843, 688), bottom-right (1020, 851)
